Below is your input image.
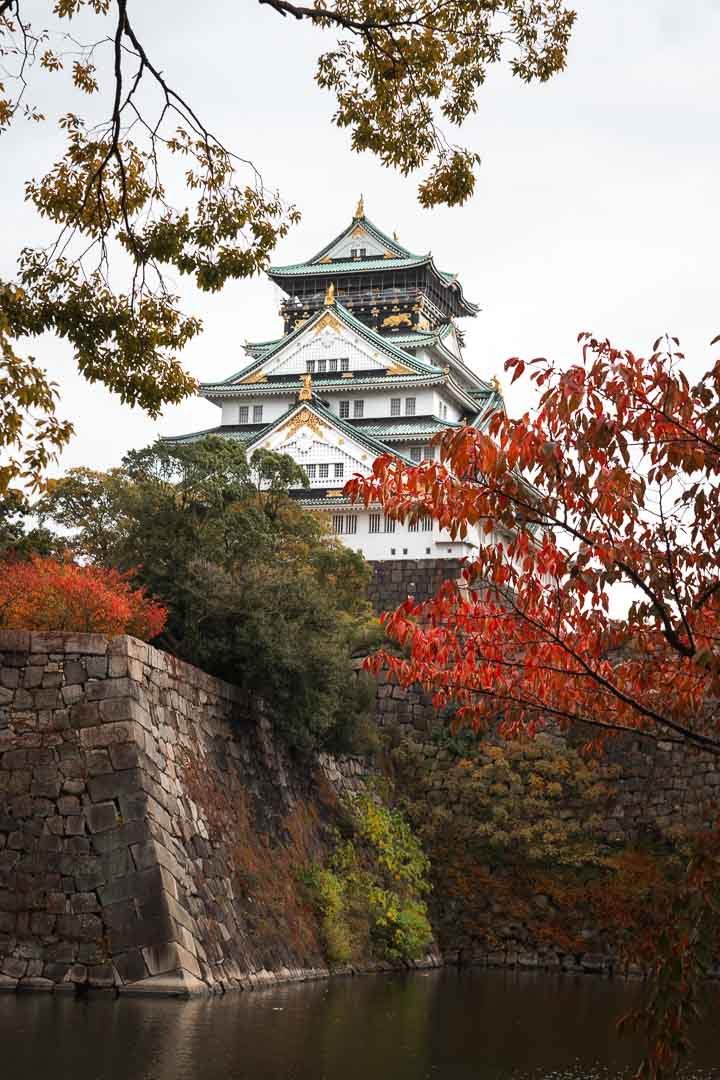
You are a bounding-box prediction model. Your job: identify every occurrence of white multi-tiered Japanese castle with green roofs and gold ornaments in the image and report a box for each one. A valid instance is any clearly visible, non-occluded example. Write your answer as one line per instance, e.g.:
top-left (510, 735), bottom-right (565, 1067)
top-left (169, 199), bottom-right (503, 562)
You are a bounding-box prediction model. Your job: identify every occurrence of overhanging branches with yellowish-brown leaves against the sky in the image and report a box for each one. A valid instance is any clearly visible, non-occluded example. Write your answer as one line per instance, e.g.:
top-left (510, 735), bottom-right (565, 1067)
top-left (0, 0), bottom-right (574, 491)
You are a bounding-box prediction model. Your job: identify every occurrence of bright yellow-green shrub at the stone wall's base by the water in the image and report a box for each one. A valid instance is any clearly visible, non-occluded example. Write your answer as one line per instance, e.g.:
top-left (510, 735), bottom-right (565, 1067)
top-left (304, 794), bottom-right (433, 964)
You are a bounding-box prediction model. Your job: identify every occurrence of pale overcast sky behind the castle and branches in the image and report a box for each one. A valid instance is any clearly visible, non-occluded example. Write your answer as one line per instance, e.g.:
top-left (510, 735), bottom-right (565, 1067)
top-left (5, 0), bottom-right (720, 469)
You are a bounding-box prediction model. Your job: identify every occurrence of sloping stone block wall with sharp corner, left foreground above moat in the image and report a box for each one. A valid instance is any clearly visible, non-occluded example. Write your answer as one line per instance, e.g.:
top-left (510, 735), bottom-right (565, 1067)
top-left (0, 631), bottom-right (382, 994)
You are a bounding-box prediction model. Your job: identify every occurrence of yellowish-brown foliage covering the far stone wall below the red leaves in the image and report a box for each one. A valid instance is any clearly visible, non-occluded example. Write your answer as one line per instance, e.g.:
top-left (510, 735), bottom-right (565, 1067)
top-left (394, 733), bottom-right (609, 868)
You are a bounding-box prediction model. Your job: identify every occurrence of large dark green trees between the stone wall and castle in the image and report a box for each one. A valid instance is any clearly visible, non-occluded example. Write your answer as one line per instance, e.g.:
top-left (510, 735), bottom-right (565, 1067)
top-left (38, 437), bottom-right (379, 748)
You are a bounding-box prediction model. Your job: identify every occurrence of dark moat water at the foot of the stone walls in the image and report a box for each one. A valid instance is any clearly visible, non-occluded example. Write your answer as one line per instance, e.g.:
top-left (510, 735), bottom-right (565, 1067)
top-left (0, 971), bottom-right (720, 1080)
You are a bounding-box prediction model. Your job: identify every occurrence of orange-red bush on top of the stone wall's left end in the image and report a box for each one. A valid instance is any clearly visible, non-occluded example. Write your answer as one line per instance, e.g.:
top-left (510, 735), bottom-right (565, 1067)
top-left (0, 556), bottom-right (166, 640)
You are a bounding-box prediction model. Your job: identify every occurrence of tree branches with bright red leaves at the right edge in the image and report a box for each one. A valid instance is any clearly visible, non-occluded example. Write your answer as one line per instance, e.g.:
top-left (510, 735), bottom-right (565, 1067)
top-left (348, 334), bottom-right (720, 1077)
